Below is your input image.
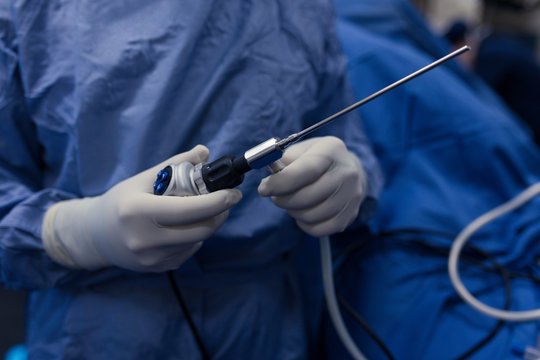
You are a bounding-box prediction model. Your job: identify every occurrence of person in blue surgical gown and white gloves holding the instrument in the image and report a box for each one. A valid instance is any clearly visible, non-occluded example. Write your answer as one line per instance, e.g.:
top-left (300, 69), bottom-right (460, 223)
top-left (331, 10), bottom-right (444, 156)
top-left (0, 0), bottom-right (380, 359)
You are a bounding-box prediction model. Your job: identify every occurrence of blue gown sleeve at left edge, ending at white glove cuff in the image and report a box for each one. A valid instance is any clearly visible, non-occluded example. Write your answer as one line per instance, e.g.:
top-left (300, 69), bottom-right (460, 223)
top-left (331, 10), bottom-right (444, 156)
top-left (0, 7), bottom-right (81, 288)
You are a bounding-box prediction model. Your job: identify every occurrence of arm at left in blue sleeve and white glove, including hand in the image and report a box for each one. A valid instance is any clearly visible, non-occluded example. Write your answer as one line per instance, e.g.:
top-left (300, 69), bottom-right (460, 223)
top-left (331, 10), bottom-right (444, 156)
top-left (0, 9), bottom-right (241, 289)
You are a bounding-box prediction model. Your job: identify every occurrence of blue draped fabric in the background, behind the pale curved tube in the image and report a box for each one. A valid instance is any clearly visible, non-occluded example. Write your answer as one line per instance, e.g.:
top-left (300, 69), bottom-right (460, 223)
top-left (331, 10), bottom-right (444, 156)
top-left (327, 0), bottom-right (540, 359)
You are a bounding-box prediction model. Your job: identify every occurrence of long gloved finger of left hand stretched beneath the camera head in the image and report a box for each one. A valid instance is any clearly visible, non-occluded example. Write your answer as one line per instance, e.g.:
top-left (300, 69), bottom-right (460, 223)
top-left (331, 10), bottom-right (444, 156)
top-left (134, 189), bottom-right (242, 227)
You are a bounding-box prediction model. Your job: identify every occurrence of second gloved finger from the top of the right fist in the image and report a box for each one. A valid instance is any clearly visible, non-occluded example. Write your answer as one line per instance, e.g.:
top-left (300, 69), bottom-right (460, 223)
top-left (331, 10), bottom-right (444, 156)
top-left (272, 171), bottom-right (341, 210)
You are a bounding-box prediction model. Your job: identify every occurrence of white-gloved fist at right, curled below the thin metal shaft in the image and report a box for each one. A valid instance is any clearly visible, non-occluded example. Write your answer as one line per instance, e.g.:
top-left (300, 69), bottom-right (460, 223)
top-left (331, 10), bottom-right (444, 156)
top-left (258, 136), bottom-right (367, 237)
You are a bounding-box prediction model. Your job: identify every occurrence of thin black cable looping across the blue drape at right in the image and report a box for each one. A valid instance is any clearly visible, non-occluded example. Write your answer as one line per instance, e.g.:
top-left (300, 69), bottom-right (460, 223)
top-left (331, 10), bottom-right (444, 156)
top-left (339, 229), bottom-right (516, 360)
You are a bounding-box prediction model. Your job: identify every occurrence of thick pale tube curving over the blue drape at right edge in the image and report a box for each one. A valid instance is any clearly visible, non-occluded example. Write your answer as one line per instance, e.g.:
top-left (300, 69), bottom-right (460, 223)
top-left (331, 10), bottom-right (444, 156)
top-left (448, 183), bottom-right (540, 321)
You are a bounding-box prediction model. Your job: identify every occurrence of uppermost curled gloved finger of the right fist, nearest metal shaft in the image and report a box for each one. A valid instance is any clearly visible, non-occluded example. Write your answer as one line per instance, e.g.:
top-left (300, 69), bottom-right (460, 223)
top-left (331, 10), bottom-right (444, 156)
top-left (257, 154), bottom-right (334, 196)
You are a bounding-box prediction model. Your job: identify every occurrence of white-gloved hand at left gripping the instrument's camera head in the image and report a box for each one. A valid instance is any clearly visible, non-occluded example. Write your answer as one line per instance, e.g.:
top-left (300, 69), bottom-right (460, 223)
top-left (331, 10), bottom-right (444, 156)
top-left (42, 145), bottom-right (242, 272)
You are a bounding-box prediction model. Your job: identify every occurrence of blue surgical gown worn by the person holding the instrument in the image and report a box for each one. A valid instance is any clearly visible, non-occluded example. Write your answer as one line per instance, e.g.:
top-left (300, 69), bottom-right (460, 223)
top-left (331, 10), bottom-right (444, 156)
top-left (0, 0), bottom-right (381, 359)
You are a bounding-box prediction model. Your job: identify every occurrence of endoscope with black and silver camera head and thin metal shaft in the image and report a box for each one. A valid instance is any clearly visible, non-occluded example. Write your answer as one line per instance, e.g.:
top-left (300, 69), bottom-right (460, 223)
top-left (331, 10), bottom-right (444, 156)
top-left (153, 46), bottom-right (470, 196)
